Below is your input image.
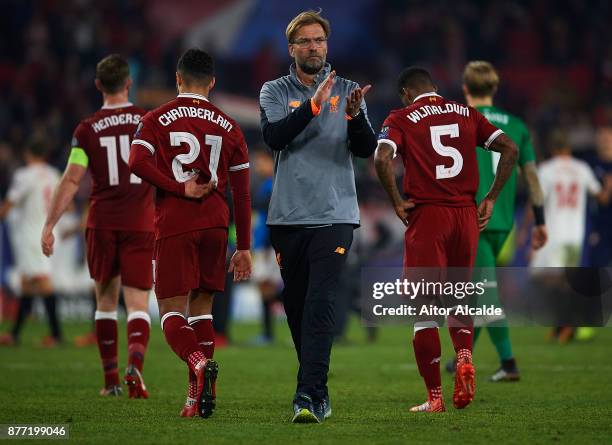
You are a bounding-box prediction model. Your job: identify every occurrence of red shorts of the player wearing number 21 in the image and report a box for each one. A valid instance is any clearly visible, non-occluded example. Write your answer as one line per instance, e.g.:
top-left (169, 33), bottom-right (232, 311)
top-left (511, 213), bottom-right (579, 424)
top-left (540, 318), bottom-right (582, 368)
top-left (153, 228), bottom-right (227, 299)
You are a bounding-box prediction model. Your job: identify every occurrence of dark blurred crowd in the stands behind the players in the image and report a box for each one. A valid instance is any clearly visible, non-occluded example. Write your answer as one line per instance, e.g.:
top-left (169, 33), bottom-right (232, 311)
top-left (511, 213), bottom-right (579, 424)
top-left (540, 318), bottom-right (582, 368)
top-left (0, 0), bottom-right (612, 338)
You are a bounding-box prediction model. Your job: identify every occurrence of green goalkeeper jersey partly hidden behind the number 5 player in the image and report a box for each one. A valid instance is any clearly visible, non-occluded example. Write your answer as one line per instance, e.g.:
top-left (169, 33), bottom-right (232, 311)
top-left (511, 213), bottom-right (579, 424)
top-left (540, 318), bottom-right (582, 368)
top-left (476, 106), bottom-right (535, 231)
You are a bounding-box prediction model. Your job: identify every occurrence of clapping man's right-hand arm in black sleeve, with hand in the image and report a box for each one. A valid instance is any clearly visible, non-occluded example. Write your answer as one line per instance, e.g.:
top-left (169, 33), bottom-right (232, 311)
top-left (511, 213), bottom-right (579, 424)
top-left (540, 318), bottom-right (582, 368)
top-left (345, 85), bottom-right (376, 158)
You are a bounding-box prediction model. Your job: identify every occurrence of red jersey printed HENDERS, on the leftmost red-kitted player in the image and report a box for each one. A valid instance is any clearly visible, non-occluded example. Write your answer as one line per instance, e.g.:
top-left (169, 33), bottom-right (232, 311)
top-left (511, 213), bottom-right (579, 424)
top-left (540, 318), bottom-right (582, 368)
top-left (72, 103), bottom-right (154, 232)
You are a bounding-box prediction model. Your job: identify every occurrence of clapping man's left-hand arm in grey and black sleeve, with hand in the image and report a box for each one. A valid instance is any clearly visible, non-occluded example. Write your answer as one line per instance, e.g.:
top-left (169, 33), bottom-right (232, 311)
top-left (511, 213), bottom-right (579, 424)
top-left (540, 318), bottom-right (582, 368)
top-left (259, 71), bottom-right (336, 151)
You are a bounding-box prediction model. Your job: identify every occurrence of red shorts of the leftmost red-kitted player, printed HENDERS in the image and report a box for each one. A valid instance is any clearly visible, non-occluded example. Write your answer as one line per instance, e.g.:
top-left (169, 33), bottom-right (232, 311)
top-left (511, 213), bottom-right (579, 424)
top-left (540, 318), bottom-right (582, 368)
top-left (85, 228), bottom-right (155, 289)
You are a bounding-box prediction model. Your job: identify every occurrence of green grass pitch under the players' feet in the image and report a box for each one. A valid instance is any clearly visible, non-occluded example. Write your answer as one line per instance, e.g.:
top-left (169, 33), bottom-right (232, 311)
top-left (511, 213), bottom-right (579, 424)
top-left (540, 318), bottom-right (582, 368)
top-left (0, 322), bottom-right (612, 445)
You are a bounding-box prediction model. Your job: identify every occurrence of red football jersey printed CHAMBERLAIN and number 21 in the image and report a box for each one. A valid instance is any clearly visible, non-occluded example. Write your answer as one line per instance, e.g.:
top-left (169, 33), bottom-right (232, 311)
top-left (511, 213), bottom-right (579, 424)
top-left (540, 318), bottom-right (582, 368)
top-left (133, 93), bottom-right (249, 239)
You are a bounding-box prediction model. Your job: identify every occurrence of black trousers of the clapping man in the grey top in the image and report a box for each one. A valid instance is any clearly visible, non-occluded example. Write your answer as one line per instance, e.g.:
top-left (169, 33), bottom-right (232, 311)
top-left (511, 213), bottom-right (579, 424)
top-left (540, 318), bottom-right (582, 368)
top-left (270, 224), bottom-right (354, 401)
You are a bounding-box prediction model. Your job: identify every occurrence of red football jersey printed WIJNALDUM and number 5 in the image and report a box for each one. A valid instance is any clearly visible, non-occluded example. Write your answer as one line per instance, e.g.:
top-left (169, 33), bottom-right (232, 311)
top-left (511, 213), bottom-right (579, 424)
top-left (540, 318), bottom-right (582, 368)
top-left (378, 93), bottom-right (503, 207)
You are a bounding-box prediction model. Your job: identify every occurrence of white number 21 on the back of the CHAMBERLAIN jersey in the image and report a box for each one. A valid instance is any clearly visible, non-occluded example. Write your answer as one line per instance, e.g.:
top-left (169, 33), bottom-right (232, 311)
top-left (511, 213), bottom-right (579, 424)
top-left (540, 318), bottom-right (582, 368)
top-left (170, 131), bottom-right (223, 182)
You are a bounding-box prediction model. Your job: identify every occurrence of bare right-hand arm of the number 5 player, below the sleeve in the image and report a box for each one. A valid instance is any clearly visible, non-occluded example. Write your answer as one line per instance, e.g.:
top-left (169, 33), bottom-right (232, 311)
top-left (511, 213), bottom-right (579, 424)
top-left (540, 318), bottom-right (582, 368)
top-left (478, 131), bottom-right (518, 230)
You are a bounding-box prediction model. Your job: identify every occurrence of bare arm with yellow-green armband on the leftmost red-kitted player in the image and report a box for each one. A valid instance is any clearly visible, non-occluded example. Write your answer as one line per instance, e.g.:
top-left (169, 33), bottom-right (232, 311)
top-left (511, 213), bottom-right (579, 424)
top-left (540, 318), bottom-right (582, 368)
top-left (40, 160), bottom-right (88, 256)
